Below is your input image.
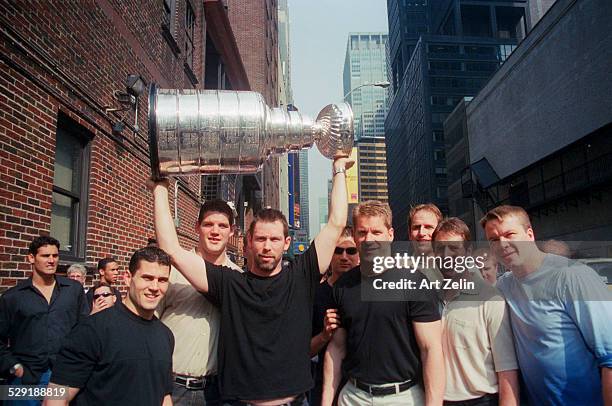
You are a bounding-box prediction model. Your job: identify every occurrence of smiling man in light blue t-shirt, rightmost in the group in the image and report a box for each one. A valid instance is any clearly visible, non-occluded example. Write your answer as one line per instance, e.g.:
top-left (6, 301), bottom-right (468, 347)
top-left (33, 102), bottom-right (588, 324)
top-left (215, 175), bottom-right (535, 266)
top-left (480, 206), bottom-right (612, 405)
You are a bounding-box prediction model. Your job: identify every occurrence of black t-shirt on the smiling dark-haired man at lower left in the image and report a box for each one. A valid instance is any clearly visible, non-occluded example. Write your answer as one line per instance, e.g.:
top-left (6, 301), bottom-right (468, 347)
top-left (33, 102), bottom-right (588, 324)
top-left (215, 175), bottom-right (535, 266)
top-left (51, 302), bottom-right (174, 406)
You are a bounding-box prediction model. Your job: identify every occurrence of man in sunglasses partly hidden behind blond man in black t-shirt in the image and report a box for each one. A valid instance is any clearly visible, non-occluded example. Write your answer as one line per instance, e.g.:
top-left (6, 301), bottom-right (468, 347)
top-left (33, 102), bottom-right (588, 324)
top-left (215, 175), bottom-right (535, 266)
top-left (309, 226), bottom-right (359, 405)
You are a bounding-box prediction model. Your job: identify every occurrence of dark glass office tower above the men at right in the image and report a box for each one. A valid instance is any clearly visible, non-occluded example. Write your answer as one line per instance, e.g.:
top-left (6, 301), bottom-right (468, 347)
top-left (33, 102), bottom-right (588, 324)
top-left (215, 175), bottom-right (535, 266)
top-left (385, 0), bottom-right (531, 238)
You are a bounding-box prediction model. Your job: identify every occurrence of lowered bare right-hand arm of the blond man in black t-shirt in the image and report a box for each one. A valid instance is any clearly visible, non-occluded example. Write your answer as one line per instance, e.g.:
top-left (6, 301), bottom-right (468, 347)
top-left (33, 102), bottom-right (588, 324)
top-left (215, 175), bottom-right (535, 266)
top-left (412, 320), bottom-right (446, 406)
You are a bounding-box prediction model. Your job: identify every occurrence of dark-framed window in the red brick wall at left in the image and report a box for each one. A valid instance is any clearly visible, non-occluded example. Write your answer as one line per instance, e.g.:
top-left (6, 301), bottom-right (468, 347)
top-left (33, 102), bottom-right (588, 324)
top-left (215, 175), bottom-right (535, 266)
top-left (51, 115), bottom-right (91, 260)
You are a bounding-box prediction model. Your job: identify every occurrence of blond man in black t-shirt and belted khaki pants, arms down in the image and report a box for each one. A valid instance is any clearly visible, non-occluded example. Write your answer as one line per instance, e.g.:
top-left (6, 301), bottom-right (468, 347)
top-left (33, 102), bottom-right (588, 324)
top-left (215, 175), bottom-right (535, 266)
top-left (321, 200), bottom-right (444, 406)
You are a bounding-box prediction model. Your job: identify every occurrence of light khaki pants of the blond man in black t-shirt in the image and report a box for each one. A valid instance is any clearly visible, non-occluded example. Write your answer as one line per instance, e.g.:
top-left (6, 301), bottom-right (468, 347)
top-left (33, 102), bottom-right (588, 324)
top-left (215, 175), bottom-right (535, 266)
top-left (338, 380), bottom-right (425, 406)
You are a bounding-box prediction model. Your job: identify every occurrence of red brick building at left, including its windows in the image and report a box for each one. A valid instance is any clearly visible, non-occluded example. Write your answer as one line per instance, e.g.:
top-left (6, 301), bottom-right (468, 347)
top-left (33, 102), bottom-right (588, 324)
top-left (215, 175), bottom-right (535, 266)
top-left (0, 0), bottom-right (250, 291)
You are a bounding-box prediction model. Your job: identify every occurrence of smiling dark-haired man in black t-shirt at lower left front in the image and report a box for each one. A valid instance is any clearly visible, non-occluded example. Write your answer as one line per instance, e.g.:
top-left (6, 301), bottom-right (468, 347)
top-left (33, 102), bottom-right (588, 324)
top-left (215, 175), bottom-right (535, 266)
top-left (44, 247), bottom-right (174, 406)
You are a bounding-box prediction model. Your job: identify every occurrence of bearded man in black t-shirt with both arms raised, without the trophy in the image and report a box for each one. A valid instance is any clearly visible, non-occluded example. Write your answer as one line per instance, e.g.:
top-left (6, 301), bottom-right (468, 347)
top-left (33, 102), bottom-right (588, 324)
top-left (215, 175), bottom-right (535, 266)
top-left (152, 157), bottom-right (354, 406)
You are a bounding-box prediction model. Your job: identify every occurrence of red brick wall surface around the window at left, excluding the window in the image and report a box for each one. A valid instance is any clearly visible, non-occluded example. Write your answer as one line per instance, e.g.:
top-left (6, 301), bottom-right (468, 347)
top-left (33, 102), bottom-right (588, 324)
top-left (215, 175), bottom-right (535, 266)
top-left (0, 0), bottom-right (205, 291)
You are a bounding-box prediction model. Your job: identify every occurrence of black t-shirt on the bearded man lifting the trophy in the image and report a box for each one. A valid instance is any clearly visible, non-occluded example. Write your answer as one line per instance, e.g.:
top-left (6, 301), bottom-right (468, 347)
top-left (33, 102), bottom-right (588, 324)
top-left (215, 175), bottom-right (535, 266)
top-left (206, 244), bottom-right (321, 400)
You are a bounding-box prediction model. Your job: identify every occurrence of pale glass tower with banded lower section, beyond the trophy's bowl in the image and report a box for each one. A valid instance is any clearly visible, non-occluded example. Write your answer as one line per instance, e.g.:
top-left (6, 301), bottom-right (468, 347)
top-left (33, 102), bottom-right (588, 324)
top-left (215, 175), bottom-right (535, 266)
top-left (343, 33), bottom-right (388, 202)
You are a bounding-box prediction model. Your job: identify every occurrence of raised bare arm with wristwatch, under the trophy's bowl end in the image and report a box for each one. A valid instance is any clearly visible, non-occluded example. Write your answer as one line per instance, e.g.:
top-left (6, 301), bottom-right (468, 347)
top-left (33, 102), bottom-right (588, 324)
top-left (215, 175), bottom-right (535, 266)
top-left (314, 157), bottom-right (355, 273)
